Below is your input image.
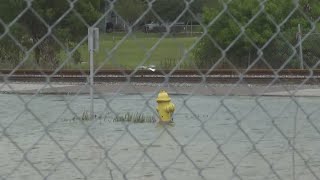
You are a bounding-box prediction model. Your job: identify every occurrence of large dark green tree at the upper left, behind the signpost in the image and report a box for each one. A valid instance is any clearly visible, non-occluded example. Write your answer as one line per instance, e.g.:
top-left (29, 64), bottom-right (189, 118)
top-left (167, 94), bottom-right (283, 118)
top-left (0, 0), bottom-right (102, 66)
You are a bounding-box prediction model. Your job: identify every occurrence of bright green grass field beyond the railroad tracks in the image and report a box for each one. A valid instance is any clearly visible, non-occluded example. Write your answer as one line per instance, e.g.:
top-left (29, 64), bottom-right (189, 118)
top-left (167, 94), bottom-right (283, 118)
top-left (68, 33), bottom-right (197, 69)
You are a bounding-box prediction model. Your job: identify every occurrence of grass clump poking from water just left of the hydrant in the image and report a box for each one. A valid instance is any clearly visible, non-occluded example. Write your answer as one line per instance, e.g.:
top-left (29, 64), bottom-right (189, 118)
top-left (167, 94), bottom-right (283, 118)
top-left (113, 113), bottom-right (156, 123)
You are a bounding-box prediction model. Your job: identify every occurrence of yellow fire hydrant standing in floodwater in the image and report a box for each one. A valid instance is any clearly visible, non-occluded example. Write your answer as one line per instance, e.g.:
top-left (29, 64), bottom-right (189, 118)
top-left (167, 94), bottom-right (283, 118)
top-left (157, 90), bottom-right (175, 123)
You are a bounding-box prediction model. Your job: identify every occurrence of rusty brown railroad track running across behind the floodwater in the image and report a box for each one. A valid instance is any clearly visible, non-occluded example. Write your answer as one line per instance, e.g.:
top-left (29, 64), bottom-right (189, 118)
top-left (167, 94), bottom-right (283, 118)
top-left (0, 69), bottom-right (320, 84)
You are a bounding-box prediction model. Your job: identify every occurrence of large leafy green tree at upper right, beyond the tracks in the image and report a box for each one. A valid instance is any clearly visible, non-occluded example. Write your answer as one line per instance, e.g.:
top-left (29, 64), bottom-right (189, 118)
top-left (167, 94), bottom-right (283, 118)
top-left (194, 0), bottom-right (320, 68)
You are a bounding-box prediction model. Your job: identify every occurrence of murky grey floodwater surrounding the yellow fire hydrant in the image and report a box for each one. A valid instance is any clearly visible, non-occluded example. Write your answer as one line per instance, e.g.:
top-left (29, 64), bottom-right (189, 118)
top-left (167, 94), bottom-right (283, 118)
top-left (0, 94), bottom-right (320, 180)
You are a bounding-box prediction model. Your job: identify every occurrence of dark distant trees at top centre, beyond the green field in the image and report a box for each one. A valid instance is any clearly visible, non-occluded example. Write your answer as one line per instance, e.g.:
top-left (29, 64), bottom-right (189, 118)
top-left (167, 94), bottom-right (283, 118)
top-left (109, 0), bottom-right (210, 31)
